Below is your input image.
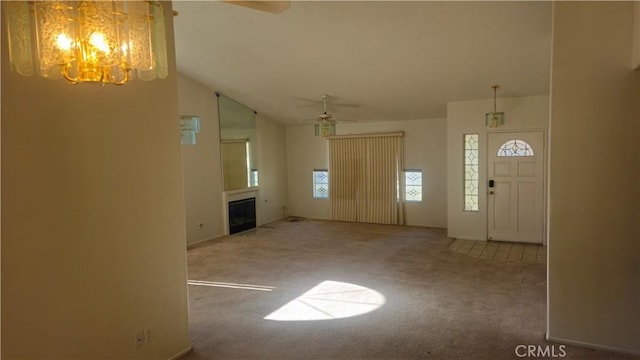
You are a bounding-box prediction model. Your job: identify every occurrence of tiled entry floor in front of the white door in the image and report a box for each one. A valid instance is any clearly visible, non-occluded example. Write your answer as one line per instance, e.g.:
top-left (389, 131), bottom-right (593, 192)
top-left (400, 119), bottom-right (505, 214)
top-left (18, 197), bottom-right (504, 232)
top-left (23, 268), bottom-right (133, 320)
top-left (449, 239), bottom-right (547, 264)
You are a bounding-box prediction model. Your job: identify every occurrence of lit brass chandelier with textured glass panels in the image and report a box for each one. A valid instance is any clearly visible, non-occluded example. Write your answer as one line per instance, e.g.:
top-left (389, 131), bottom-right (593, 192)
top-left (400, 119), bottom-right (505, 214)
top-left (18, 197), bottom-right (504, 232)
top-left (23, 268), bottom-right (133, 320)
top-left (2, 1), bottom-right (168, 85)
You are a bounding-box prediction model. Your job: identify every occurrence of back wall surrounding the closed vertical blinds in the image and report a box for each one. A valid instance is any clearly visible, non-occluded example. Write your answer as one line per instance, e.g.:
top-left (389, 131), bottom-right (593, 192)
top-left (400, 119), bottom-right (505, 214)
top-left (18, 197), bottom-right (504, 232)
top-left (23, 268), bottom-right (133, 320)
top-left (287, 119), bottom-right (447, 228)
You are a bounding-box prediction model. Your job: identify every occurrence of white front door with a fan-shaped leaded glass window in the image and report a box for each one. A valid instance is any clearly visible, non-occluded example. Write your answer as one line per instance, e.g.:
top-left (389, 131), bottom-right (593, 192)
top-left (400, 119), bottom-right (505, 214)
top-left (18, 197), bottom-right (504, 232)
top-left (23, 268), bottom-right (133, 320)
top-left (488, 131), bottom-right (544, 244)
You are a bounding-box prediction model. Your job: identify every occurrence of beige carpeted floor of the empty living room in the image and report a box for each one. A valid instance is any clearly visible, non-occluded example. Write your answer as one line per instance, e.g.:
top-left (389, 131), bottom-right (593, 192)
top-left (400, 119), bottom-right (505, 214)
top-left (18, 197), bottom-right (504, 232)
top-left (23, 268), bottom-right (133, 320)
top-left (183, 220), bottom-right (633, 360)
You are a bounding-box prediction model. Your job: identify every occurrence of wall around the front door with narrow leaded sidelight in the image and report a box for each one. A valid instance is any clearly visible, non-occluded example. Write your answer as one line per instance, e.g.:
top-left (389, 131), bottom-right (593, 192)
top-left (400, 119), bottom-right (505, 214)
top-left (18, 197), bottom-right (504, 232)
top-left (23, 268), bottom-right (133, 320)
top-left (446, 95), bottom-right (549, 240)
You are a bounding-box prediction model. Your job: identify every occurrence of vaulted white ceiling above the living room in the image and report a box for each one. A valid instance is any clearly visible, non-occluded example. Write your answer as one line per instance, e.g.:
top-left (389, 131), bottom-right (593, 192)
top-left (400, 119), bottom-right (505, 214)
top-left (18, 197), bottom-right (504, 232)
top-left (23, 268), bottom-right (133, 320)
top-left (173, 1), bottom-right (551, 124)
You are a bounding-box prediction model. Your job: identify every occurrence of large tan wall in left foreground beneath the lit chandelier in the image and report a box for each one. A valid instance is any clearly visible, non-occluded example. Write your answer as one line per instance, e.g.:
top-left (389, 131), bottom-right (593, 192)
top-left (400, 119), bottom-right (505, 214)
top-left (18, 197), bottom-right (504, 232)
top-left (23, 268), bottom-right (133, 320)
top-left (1, 2), bottom-right (190, 359)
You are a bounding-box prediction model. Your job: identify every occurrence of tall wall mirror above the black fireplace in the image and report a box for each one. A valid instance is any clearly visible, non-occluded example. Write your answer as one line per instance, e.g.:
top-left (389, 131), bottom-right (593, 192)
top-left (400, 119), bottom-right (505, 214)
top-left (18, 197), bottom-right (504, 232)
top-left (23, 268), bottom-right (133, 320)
top-left (216, 93), bottom-right (258, 191)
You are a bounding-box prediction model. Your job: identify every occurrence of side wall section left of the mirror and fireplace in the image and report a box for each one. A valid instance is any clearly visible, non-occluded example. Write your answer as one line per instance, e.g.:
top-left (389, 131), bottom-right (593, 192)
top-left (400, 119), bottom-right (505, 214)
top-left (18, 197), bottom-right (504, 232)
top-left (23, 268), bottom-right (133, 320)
top-left (178, 74), bottom-right (224, 244)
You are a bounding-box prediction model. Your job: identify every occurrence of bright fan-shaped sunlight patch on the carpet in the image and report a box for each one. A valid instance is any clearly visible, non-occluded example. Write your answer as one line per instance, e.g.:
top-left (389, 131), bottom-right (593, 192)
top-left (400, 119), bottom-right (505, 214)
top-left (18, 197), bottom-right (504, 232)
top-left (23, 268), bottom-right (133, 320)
top-left (264, 280), bottom-right (386, 321)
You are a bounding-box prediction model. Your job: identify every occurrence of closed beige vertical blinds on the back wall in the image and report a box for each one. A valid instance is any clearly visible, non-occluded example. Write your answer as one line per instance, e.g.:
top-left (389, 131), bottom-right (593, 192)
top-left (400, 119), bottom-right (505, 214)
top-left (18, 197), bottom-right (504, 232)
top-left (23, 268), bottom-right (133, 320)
top-left (329, 133), bottom-right (404, 224)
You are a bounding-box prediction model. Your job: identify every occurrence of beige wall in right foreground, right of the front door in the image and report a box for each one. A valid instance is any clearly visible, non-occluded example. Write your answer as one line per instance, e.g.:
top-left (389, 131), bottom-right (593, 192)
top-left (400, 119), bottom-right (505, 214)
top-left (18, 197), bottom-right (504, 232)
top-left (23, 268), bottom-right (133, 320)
top-left (547, 2), bottom-right (640, 353)
